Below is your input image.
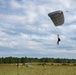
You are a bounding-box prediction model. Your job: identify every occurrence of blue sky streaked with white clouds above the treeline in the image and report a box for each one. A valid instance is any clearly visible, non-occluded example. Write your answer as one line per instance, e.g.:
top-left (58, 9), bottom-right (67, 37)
top-left (0, 0), bottom-right (76, 59)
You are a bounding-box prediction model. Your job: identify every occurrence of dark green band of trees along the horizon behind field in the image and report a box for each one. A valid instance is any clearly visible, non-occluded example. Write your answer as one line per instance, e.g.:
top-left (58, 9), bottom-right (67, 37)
top-left (0, 57), bottom-right (76, 64)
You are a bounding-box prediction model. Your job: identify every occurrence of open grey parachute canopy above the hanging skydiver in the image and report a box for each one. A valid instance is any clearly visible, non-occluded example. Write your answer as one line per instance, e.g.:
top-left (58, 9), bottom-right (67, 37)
top-left (48, 10), bottom-right (64, 26)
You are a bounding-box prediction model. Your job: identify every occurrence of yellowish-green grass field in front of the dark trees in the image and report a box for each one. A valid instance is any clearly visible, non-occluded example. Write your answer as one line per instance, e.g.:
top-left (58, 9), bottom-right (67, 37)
top-left (0, 64), bottom-right (76, 75)
